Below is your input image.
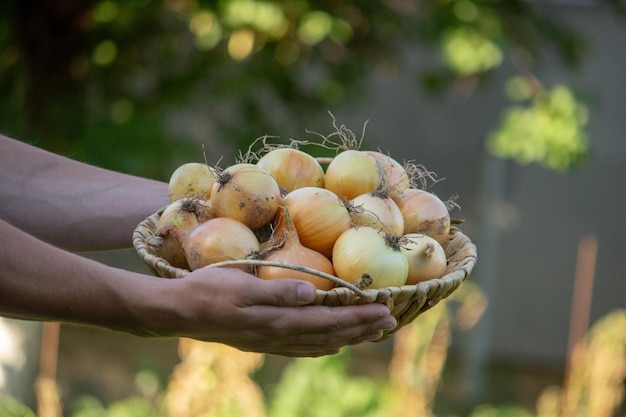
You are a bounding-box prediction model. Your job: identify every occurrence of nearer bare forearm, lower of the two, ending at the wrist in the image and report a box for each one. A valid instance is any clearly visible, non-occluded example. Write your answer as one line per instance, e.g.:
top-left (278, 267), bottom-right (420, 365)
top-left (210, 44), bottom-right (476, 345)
top-left (0, 216), bottom-right (167, 335)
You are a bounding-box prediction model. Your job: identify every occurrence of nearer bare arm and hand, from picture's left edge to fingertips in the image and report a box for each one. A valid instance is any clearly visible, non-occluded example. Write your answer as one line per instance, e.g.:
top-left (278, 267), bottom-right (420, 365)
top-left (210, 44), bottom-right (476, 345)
top-left (0, 216), bottom-right (395, 356)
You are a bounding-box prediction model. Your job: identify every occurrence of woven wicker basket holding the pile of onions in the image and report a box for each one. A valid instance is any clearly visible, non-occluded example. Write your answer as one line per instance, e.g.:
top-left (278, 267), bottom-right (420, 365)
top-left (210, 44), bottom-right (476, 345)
top-left (133, 212), bottom-right (476, 340)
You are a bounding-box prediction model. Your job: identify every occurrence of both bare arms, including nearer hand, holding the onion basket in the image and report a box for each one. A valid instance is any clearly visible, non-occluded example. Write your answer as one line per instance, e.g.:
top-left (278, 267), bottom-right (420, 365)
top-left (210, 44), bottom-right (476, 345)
top-left (0, 135), bottom-right (396, 356)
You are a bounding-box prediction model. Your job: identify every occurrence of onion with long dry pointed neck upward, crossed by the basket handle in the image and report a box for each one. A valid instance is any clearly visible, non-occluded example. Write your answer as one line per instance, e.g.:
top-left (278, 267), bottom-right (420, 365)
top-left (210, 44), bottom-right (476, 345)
top-left (256, 207), bottom-right (335, 290)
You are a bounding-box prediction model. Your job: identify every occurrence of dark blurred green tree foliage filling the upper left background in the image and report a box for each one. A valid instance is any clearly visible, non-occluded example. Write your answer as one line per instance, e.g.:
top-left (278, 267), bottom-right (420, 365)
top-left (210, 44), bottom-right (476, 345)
top-left (0, 0), bottom-right (622, 178)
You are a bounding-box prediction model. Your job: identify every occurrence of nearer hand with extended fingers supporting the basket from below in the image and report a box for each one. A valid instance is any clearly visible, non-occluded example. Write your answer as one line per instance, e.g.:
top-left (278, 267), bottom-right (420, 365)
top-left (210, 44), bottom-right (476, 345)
top-left (152, 268), bottom-right (396, 356)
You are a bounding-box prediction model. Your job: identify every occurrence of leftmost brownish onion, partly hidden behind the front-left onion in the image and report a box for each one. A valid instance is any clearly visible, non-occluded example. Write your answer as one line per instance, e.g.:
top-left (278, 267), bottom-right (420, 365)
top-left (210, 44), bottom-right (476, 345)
top-left (151, 198), bottom-right (215, 269)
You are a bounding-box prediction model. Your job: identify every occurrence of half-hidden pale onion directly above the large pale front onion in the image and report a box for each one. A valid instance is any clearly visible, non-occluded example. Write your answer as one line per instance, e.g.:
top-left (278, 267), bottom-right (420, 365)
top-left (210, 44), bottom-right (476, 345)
top-left (349, 191), bottom-right (404, 235)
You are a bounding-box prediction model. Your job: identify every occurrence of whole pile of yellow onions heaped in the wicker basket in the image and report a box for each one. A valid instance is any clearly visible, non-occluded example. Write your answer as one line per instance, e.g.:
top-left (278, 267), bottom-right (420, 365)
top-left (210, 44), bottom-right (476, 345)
top-left (152, 138), bottom-right (450, 290)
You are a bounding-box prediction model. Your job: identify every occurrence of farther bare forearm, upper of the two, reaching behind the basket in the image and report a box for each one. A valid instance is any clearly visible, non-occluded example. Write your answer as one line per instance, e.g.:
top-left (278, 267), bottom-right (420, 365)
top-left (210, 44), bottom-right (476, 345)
top-left (0, 135), bottom-right (168, 251)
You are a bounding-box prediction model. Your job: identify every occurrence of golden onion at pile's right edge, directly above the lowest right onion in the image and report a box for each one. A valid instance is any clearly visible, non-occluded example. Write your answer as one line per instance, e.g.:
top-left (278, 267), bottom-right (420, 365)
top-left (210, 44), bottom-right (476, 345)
top-left (391, 188), bottom-right (450, 245)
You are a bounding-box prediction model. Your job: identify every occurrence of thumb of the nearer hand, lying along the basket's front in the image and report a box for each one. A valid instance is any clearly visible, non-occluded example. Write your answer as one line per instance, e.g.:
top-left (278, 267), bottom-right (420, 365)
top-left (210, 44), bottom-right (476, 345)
top-left (249, 279), bottom-right (315, 307)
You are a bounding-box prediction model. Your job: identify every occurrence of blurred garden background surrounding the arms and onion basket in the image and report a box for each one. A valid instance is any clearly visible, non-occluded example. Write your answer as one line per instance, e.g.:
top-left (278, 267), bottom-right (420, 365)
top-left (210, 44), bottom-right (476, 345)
top-left (0, 0), bottom-right (626, 417)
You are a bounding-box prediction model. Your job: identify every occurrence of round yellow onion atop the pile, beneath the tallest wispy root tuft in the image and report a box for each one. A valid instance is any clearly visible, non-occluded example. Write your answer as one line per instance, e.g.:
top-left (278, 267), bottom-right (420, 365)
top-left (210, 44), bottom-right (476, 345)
top-left (324, 149), bottom-right (388, 200)
